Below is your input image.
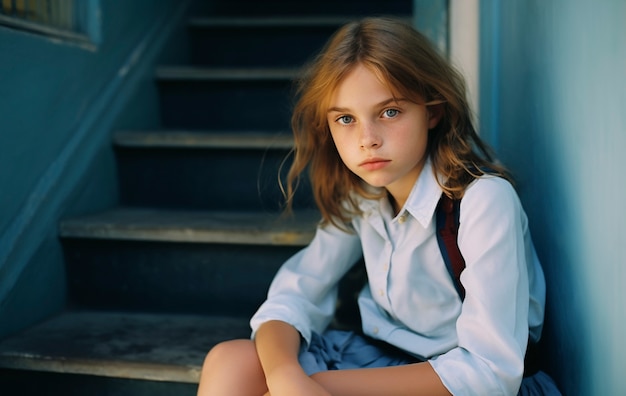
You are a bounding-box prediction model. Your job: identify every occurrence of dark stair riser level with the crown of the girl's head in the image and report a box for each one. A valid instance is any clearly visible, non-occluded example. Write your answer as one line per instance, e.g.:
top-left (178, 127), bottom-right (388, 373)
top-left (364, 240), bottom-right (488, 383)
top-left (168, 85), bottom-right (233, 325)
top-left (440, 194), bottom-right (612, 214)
top-left (190, 25), bottom-right (338, 67)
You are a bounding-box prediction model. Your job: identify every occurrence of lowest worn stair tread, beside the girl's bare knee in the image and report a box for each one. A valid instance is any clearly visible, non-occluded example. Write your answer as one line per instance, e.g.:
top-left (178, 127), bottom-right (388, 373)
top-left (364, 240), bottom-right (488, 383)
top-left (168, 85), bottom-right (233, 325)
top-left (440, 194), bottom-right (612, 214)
top-left (0, 311), bottom-right (250, 383)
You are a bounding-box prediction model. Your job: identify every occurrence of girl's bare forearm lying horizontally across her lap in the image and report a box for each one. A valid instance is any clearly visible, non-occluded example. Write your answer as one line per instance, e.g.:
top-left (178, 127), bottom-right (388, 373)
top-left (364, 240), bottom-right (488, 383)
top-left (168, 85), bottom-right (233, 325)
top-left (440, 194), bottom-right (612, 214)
top-left (313, 362), bottom-right (450, 396)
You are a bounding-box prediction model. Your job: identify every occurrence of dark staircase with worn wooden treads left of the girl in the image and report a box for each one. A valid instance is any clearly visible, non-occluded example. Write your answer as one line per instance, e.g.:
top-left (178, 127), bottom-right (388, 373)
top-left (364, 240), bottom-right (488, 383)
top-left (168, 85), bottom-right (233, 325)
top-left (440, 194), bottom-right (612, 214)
top-left (0, 0), bottom-right (412, 395)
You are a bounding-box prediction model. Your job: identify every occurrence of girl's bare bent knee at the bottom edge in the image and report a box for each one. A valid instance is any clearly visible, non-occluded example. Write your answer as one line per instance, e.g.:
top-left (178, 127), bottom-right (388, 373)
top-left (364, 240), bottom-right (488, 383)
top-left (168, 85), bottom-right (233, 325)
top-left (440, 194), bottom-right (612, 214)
top-left (198, 340), bottom-right (267, 396)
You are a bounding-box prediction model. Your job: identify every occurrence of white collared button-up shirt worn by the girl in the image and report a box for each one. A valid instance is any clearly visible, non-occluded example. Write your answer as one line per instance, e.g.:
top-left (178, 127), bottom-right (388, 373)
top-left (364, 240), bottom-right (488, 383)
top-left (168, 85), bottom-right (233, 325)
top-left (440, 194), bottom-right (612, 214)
top-left (251, 162), bottom-right (545, 395)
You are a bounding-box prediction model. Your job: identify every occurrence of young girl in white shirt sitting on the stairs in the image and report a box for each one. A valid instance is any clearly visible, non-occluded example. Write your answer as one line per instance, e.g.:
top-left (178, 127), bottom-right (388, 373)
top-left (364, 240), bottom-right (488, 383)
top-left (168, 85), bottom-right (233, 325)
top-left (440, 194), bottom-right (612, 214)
top-left (198, 18), bottom-right (558, 396)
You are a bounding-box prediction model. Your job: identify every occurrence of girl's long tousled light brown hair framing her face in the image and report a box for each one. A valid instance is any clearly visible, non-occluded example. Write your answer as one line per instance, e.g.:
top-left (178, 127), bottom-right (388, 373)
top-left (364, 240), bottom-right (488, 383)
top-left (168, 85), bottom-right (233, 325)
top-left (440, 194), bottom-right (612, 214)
top-left (285, 18), bottom-right (508, 226)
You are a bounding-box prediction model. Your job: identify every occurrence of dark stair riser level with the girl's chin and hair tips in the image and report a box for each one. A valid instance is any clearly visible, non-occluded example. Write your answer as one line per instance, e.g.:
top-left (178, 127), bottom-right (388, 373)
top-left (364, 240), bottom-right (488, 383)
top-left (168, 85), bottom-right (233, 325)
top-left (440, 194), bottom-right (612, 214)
top-left (117, 148), bottom-right (314, 211)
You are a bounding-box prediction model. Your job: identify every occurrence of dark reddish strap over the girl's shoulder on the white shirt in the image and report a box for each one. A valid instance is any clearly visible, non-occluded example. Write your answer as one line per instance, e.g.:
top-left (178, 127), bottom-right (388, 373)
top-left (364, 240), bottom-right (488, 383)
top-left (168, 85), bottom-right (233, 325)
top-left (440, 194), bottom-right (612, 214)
top-left (436, 194), bottom-right (465, 301)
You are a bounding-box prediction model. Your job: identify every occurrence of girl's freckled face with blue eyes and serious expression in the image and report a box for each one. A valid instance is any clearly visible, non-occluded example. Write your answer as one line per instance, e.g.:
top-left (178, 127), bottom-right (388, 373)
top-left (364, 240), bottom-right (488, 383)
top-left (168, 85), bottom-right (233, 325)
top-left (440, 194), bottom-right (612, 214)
top-left (327, 64), bottom-right (440, 206)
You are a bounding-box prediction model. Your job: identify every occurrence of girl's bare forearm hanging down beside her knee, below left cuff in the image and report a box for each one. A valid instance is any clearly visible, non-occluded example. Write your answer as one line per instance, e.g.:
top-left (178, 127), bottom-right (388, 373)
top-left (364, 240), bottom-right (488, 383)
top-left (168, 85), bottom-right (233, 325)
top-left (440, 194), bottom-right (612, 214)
top-left (255, 320), bottom-right (330, 396)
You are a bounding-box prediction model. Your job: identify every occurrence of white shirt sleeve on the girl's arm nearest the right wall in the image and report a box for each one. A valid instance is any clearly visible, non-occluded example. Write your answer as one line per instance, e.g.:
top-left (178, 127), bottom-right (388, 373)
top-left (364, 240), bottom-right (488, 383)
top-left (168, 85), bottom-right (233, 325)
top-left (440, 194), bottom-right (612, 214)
top-left (431, 177), bottom-right (545, 395)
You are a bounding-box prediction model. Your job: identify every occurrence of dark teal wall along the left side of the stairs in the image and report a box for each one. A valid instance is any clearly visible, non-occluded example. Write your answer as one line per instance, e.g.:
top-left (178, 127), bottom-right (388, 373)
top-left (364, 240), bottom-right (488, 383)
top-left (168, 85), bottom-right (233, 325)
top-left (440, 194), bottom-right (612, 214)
top-left (0, 0), bottom-right (187, 338)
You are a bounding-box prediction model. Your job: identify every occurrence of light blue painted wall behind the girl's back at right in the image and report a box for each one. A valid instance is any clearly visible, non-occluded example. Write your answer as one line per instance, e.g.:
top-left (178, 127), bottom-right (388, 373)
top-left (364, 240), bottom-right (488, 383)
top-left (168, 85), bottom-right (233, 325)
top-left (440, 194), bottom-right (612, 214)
top-left (481, 0), bottom-right (626, 395)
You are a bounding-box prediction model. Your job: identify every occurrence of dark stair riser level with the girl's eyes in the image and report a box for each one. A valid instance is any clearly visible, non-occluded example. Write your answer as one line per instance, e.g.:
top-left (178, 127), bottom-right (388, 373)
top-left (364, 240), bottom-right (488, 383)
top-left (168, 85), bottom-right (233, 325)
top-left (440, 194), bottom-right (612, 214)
top-left (159, 79), bottom-right (292, 131)
